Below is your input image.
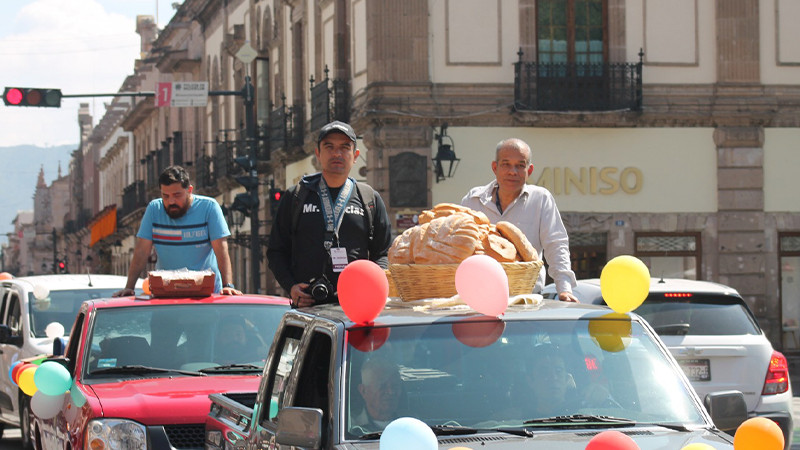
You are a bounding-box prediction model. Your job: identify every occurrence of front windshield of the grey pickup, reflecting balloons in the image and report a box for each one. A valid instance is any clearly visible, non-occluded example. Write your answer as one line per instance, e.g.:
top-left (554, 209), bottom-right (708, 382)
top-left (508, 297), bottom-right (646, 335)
top-left (345, 314), bottom-right (707, 439)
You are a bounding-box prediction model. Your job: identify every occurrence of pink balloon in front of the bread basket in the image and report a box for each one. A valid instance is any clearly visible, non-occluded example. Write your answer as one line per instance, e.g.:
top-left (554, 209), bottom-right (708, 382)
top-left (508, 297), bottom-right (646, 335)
top-left (456, 255), bottom-right (508, 316)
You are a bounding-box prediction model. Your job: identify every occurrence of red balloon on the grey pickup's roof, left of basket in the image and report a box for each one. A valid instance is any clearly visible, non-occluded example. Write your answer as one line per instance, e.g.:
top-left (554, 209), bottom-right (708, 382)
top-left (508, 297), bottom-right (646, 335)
top-left (336, 259), bottom-right (389, 323)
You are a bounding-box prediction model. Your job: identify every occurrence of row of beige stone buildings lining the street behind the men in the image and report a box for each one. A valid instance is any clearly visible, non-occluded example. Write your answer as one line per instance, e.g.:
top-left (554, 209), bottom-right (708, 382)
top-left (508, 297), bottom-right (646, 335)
top-left (42, 0), bottom-right (800, 353)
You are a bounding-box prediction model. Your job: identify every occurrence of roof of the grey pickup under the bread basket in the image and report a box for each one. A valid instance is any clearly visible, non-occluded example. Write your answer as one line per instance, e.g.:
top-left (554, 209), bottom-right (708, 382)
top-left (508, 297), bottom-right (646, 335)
top-left (292, 300), bottom-right (642, 329)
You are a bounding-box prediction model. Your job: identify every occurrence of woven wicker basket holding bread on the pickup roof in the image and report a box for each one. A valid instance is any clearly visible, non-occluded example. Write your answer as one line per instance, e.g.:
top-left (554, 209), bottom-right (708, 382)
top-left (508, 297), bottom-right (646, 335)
top-left (389, 261), bottom-right (542, 302)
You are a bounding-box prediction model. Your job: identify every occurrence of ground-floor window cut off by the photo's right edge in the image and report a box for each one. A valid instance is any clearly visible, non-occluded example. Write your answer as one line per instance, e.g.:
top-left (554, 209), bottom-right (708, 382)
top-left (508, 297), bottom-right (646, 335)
top-left (778, 232), bottom-right (800, 352)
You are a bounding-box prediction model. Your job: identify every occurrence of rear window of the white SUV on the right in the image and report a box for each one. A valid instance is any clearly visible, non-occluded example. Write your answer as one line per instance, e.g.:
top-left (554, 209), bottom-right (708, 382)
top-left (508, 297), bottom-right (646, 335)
top-left (635, 296), bottom-right (760, 336)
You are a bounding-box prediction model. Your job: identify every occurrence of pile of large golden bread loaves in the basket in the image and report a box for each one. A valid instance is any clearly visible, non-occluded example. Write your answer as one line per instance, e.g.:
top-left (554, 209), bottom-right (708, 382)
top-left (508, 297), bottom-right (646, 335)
top-left (389, 203), bottom-right (539, 264)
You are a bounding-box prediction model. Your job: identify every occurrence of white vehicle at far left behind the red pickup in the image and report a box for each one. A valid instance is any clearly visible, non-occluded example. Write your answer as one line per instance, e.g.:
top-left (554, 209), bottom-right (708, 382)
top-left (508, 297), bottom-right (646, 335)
top-left (0, 274), bottom-right (141, 448)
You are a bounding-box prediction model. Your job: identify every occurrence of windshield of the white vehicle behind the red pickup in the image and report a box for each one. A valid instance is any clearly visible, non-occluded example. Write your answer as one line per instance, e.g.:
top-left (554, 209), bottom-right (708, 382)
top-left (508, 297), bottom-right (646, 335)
top-left (28, 288), bottom-right (119, 338)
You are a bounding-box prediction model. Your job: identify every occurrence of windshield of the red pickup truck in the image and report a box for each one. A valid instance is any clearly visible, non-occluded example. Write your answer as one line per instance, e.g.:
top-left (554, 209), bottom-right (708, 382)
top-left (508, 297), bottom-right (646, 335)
top-left (84, 303), bottom-right (288, 378)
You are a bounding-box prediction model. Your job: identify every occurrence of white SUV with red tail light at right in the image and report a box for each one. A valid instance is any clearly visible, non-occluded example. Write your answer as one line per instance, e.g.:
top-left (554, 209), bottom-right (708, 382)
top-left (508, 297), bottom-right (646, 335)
top-left (542, 278), bottom-right (793, 448)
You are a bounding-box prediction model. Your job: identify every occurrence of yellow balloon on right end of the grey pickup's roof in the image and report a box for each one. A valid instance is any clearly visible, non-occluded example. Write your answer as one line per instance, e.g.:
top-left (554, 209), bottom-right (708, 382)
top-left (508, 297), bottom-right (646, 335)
top-left (600, 255), bottom-right (650, 314)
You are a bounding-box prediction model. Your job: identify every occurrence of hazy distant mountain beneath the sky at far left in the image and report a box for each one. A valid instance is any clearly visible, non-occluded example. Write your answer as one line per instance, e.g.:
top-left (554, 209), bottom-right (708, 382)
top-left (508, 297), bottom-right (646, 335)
top-left (0, 144), bottom-right (78, 244)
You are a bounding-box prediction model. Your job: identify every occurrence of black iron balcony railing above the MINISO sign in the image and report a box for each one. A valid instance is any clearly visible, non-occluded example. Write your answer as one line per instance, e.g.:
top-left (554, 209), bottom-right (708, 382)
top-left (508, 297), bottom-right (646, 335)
top-left (514, 50), bottom-right (644, 111)
